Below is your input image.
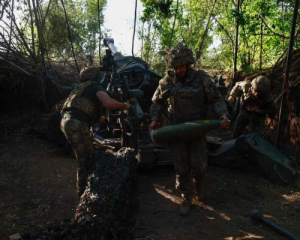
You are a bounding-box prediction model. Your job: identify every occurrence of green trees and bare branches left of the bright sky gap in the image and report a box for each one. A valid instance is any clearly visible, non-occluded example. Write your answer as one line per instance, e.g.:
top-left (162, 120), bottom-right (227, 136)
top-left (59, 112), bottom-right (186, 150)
top-left (0, 0), bottom-right (106, 71)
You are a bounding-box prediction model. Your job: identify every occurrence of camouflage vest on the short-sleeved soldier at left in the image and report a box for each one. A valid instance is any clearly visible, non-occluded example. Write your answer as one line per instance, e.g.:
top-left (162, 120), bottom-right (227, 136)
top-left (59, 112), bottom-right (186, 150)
top-left (62, 81), bottom-right (96, 118)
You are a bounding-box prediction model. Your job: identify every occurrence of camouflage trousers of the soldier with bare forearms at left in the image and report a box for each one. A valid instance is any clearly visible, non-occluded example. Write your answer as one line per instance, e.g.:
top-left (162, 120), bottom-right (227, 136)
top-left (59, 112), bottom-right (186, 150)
top-left (60, 118), bottom-right (94, 196)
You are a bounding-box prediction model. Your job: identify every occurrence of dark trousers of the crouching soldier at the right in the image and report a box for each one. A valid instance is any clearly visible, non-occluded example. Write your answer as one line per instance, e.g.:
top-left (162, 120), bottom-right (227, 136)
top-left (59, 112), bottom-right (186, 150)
top-left (232, 112), bottom-right (264, 138)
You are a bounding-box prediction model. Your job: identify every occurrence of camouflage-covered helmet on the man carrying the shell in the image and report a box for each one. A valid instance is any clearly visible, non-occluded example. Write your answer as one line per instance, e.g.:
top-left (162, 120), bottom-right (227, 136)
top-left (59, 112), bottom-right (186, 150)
top-left (165, 43), bottom-right (195, 68)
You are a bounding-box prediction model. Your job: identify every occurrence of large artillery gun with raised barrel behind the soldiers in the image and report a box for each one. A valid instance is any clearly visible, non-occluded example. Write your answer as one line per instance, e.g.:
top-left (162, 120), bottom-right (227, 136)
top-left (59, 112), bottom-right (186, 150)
top-left (94, 38), bottom-right (162, 166)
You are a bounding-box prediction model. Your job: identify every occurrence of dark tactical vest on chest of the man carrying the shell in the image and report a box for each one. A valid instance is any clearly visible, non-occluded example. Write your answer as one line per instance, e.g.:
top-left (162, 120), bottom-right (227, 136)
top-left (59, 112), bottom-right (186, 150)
top-left (168, 78), bottom-right (207, 124)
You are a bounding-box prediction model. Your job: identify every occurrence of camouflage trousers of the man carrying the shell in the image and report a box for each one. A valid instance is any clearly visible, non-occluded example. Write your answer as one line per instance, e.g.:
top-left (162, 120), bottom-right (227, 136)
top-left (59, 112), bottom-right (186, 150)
top-left (169, 137), bottom-right (208, 198)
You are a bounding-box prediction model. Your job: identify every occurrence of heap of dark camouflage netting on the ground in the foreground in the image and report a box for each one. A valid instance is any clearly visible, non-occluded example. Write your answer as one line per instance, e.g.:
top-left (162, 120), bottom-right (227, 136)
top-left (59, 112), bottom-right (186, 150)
top-left (75, 148), bottom-right (137, 239)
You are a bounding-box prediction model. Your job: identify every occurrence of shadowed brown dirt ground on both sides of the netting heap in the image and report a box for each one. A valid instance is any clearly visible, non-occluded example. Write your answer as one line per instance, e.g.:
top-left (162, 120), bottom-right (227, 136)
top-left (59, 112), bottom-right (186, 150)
top-left (0, 122), bottom-right (300, 240)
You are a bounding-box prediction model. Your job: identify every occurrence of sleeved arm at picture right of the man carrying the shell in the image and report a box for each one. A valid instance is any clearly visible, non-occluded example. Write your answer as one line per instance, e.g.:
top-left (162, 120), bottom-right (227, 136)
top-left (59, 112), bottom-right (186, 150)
top-left (204, 74), bottom-right (228, 118)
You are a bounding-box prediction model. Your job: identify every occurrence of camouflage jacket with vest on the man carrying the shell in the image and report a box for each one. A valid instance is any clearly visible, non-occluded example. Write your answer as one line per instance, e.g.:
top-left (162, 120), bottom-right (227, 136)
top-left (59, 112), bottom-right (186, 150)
top-left (150, 69), bottom-right (228, 124)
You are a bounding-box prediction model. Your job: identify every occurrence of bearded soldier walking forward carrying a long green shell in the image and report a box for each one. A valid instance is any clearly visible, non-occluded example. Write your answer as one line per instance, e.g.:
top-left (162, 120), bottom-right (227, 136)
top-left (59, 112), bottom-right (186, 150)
top-left (149, 44), bottom-right (229, 216)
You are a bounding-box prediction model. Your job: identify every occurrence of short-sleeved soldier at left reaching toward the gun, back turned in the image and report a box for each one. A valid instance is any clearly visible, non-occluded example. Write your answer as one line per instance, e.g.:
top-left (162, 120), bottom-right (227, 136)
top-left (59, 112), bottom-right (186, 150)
top-left (60, 67), bottom-right (130, 197)
